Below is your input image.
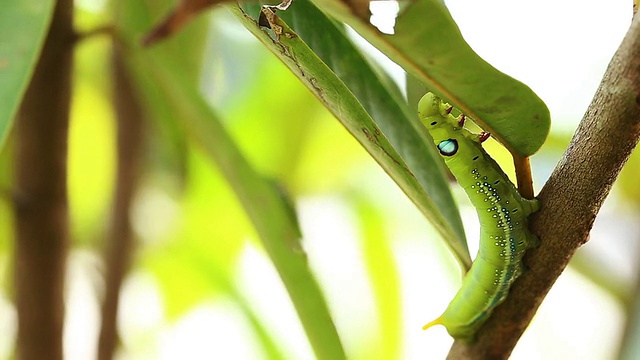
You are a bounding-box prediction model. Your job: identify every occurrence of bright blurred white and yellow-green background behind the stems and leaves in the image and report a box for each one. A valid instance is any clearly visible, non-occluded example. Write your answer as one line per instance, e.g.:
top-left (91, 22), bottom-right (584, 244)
top-left (0, 0), bottom-right (640, 360)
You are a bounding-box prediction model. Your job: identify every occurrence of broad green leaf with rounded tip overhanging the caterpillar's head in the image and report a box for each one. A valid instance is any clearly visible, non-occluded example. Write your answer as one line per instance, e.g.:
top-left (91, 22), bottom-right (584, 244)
top-left (316, 0), bottom-right (550, 157)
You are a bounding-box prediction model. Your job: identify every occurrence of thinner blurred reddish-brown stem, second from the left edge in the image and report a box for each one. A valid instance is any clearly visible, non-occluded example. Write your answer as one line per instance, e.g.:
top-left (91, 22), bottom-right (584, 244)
top-left (98, 40), bottom-right (144, 360)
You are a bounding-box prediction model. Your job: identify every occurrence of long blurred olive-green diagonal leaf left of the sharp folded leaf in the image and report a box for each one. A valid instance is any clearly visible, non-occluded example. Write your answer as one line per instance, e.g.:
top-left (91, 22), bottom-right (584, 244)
top-left (117, 9), bottom-right (345, 359)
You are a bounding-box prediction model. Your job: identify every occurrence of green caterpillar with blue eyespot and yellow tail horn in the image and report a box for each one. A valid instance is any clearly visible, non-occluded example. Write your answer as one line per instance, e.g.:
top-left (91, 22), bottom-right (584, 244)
top-left (418, 93), bottom-right (540, 341)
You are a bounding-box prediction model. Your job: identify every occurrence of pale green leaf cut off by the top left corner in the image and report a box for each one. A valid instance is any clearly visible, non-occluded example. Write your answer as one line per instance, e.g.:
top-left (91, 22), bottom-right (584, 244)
top-left (0, 0), bottom-right (55, 148)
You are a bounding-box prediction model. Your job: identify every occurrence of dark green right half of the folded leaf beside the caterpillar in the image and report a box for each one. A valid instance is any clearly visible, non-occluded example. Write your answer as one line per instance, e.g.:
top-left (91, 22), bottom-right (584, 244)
top-left (280, 0), bottom-right (470, 269)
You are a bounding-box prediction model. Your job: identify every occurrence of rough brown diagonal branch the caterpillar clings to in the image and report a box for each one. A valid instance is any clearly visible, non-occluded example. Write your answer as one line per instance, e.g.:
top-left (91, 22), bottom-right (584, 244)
top-left (449, 12), bottom-right (640, 359)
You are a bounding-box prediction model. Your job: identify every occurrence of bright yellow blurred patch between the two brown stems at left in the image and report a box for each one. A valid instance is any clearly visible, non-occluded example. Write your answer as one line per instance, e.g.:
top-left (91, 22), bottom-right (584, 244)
top-left (67, 37), bottom-right (116, 246)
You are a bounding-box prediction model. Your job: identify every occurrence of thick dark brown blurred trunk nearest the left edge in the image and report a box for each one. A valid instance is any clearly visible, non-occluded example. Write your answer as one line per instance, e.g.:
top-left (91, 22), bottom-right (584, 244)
top-left (14, 0), bottom-right (74, 360)
